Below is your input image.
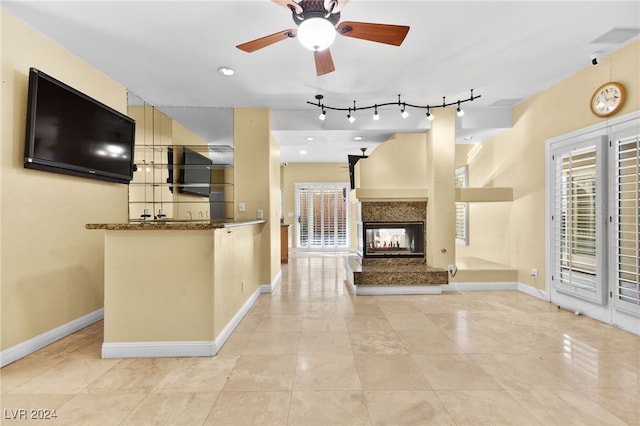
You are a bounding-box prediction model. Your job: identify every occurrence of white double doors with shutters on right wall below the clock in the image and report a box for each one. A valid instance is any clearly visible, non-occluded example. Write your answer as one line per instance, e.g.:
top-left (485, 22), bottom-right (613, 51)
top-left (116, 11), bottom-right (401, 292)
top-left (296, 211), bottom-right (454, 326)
top-left (547, 113), bottom-right (640, 334)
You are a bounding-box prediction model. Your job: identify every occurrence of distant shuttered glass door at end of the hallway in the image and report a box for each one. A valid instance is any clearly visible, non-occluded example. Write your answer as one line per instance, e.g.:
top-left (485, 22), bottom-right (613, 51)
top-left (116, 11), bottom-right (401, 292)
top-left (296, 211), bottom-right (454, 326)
top-left (295, 183), bottom-right (349, 250)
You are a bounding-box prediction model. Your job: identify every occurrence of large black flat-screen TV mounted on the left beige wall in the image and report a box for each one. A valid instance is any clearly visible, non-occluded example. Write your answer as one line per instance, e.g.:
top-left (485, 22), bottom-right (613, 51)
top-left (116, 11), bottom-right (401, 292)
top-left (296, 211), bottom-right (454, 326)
top-left (24, 68), bottom-right (135, 183)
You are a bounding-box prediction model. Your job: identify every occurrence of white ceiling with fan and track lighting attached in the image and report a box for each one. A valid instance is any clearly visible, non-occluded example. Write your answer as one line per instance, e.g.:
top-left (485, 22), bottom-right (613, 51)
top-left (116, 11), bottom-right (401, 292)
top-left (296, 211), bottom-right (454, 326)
top-left (1, 0), bottom-right (640, 163)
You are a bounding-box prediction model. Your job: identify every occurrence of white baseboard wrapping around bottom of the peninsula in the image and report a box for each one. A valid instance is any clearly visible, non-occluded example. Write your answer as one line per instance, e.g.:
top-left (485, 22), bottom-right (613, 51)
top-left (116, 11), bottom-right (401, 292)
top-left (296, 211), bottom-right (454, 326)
top-left (102, 286), bottom-right (262, 358)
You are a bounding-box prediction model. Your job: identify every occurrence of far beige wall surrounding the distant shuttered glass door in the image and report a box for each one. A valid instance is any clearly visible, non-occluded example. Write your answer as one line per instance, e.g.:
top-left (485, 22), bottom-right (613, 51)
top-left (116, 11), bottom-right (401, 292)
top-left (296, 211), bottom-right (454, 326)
top-left (278, 162), bottom-right (350, 248)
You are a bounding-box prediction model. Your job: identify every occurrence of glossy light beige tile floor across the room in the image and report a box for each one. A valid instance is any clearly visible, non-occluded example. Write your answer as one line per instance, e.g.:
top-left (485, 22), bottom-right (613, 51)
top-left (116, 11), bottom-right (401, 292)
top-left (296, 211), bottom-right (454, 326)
top-left (0, 254), bottom-right (640, 426)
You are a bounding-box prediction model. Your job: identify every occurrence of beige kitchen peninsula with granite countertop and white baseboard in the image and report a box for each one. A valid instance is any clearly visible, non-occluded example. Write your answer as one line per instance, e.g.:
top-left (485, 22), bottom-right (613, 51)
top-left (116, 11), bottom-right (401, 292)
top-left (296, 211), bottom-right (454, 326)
top-left (86, 219), bottom-right (266, 358)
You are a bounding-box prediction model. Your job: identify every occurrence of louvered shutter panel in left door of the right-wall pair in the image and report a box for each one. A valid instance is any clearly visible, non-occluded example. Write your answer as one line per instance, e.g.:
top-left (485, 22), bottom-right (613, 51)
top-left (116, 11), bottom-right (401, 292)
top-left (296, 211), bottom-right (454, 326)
top-left (551, 136), bottom-right (606, 303)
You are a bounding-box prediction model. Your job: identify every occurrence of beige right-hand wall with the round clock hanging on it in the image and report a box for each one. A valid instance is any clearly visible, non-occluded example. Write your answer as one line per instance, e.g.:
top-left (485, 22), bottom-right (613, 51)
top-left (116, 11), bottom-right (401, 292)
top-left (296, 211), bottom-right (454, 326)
top-left (457, 41), bottom-right (640, 289)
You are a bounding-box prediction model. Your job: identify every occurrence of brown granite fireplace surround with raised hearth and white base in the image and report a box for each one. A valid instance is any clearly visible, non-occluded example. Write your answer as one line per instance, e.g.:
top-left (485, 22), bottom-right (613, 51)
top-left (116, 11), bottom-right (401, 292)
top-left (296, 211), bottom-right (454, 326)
top-left (345, 200), bottom-right (449, 294)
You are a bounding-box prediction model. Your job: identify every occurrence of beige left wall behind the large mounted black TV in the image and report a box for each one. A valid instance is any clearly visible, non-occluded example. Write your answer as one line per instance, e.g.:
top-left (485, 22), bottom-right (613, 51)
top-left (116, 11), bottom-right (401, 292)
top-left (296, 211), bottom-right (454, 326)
top-left (0, 9), bottom-right (127, 350)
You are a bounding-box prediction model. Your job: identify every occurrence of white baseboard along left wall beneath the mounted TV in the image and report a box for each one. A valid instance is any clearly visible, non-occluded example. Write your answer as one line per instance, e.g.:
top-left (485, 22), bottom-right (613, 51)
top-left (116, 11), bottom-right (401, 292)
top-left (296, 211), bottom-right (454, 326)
top-left (0, 308), bottom-right (104, 368)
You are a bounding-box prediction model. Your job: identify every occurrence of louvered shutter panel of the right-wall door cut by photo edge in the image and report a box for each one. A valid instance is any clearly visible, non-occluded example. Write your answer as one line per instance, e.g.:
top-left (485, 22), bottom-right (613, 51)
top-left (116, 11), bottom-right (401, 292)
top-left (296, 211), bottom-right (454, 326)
top-left (611, 135), bottom-right (640, 314)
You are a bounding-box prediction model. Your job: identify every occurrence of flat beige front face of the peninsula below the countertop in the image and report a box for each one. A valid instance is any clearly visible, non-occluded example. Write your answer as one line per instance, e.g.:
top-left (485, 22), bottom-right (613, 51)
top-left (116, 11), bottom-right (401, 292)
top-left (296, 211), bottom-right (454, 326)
top-left (104, 230), bottom-right (217, 343)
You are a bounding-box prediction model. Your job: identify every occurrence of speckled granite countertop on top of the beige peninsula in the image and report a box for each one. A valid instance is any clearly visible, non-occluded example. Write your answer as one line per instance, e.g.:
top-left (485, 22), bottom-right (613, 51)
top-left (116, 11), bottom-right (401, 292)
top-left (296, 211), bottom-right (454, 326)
top-left (85, 219), bottom-right (267, 231)
